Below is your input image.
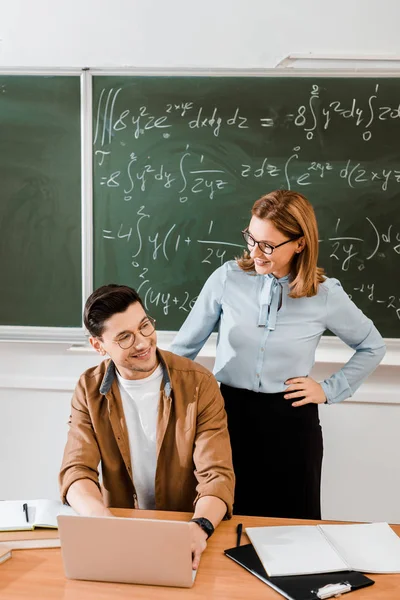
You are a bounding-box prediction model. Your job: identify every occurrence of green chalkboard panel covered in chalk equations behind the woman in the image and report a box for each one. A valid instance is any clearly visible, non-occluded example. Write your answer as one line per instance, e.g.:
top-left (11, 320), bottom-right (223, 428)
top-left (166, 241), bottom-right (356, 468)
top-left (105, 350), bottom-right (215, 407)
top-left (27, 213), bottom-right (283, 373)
top-left (93, 75), bottom-right (400, 338)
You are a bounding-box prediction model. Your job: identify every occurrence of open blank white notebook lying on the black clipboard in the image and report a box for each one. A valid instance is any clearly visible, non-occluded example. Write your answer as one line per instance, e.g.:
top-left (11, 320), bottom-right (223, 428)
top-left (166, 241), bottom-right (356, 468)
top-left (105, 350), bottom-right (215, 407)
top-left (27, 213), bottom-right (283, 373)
top-left (246, 523), bottom-right (400, 577)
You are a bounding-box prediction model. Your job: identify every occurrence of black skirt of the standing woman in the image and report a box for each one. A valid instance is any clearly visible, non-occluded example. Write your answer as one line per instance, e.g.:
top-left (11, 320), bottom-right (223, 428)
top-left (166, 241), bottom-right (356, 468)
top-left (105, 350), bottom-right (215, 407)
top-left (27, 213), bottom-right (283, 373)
top-left (221, 384), bottom-right (323, 519)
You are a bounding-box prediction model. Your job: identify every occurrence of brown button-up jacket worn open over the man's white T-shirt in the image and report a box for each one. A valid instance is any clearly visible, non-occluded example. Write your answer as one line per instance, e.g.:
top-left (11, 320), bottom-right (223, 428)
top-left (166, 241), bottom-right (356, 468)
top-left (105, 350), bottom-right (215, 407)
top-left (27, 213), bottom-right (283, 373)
top-left (60, 350), bottom-right (235, 517)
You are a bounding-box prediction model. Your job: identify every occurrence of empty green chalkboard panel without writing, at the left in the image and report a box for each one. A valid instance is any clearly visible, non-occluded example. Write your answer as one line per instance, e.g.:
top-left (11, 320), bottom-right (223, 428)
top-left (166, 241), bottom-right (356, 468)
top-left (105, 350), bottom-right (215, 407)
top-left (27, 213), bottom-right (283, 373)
top-left (0, 75), bottom-right (82, 327)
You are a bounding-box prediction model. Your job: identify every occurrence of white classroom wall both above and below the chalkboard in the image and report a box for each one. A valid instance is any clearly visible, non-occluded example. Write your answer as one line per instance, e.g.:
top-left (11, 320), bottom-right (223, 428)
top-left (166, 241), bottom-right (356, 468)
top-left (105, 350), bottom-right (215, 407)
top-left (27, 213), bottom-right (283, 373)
top-left (0, 0), bottom-right (400, 523)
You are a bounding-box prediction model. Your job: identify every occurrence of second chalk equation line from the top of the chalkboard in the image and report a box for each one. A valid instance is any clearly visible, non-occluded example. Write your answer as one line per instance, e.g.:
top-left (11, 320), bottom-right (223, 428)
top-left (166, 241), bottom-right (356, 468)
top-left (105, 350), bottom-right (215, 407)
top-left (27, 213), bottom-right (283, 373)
top-left (95, 144), bottom-right (400, 198)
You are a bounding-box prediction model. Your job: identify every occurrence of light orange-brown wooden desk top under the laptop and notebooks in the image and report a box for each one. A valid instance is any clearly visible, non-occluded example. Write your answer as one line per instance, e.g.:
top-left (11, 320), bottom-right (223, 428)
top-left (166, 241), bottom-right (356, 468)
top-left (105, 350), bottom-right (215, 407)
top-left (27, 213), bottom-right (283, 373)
top-left (0, 510), bottom-right (400, 600)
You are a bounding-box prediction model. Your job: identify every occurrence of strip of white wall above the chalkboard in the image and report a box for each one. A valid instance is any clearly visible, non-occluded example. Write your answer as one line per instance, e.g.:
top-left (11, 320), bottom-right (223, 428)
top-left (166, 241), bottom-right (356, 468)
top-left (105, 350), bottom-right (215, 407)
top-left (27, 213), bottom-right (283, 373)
top-left (0, 0), bottom-right (400, 68)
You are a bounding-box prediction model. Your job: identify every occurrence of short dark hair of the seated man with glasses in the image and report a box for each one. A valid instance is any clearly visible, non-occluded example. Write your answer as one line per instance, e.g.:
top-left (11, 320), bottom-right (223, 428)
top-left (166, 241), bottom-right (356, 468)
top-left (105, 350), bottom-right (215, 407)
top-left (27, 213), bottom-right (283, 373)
top-left (83, 283), bottom-right (144, 337)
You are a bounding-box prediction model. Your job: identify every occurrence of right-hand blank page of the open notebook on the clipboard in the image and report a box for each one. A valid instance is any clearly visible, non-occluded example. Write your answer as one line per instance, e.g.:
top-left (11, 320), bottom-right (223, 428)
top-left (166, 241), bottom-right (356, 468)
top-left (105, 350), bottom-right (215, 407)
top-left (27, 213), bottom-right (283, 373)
top-left (318, 523), bottom-right (400, 573)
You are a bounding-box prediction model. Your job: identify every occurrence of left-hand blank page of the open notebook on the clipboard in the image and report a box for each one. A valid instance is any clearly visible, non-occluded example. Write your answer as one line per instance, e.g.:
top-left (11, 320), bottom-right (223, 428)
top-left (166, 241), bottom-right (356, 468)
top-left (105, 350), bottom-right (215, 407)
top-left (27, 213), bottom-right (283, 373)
top-left (246, 525), bottom-right (348, 577)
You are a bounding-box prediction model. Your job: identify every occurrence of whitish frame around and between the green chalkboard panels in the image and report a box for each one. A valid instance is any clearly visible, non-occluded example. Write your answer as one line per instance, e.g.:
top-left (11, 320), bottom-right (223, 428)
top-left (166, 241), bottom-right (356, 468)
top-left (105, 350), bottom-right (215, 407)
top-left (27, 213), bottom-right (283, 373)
top-left (0, 67), bottom-right (400, 354)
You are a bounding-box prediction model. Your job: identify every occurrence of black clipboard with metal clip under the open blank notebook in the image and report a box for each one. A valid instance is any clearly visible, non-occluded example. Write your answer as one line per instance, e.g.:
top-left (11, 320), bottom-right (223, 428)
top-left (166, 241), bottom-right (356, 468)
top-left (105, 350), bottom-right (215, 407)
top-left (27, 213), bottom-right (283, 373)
top-left (225, 544), bottom-right (375, 600)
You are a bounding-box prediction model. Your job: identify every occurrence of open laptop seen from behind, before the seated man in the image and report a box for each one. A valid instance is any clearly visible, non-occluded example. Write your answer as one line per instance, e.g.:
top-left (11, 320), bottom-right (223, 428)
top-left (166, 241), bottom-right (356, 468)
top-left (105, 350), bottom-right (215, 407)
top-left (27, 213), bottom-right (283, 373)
top-left (57, 515), bottom-right (197, 587)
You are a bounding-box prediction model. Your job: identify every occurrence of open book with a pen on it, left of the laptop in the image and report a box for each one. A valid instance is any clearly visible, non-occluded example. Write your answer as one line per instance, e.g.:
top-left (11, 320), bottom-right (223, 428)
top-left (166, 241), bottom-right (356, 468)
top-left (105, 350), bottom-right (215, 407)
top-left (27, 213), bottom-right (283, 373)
top-left (0, 500), bottom-right (76, 531)
